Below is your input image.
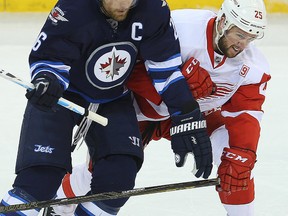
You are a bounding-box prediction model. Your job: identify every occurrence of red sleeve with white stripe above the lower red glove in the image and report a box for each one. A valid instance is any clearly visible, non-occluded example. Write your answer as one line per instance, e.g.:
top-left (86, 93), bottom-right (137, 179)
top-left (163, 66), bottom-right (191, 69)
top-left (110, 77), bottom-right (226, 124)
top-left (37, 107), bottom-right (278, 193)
top-left (222, 75), bottom-right (270, 152)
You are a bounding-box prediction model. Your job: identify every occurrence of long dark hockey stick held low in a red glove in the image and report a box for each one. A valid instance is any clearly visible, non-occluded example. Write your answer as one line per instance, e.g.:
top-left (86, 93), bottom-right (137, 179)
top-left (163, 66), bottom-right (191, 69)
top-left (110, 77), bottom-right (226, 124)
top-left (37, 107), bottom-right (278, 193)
top-left (0, 178), bottom-right (219, 213)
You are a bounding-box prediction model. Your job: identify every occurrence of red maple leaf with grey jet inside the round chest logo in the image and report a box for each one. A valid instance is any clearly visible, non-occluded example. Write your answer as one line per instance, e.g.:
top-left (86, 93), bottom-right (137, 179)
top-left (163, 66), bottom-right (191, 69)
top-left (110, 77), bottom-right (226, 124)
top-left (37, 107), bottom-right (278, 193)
top-left (100, 47), bottom-right (126, 80)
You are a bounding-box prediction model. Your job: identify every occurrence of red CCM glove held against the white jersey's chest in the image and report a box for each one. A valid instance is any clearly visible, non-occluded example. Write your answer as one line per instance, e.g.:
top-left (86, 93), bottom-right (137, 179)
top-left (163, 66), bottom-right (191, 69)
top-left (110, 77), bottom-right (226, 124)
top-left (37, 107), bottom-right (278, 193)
top-left (181, 57), bottom-right (216, 99)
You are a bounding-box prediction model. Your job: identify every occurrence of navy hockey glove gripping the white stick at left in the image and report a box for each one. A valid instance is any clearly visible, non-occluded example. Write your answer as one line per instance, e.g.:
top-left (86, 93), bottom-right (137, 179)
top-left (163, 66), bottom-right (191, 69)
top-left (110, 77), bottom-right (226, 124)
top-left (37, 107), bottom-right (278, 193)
top-left (25, 72), bottom-right (64, 112)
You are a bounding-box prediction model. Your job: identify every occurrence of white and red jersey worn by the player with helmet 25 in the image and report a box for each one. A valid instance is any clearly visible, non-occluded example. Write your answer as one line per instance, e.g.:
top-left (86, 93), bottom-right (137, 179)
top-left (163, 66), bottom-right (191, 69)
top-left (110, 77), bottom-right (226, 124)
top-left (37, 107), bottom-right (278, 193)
top-left (128, 9), bottom-right (270, 151)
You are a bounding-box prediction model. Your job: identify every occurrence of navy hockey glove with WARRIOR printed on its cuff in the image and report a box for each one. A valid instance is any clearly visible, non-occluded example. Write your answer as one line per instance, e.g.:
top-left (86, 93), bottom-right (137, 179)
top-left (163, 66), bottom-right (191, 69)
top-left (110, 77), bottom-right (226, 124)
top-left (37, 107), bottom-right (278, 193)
top-left (170, 108), bottom-right (213, 179)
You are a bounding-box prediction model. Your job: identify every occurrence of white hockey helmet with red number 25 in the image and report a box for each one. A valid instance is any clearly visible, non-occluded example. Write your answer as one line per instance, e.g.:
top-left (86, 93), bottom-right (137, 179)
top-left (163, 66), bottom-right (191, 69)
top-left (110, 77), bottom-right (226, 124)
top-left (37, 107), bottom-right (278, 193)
top-left (216, 0), bottom-right (267, 38)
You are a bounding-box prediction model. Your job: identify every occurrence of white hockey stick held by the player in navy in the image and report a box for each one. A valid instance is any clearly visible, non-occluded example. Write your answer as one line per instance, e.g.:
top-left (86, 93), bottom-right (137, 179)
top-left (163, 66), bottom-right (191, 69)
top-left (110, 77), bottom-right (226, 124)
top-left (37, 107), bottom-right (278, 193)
top-left (0, 69), bottom-right (108, 126)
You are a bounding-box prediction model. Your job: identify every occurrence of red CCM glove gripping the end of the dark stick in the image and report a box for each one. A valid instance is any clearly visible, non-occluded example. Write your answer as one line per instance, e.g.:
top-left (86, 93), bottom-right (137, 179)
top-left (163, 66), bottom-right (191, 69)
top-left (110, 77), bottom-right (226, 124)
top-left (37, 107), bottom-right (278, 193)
top-left (217, 147), bottom-right (256, 192)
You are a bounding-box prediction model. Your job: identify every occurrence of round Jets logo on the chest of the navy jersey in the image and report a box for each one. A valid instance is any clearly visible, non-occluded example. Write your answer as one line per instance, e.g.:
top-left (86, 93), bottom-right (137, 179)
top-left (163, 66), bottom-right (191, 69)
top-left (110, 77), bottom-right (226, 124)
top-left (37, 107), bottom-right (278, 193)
top-left (86, 42), bottom-right (137, 89)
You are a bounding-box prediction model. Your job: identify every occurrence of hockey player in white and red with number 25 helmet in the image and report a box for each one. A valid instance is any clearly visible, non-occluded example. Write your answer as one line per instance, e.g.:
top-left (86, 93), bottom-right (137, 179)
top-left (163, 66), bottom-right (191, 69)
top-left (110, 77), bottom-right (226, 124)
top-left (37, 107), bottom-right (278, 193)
top-left (44, 0), bottom-right (270, 216)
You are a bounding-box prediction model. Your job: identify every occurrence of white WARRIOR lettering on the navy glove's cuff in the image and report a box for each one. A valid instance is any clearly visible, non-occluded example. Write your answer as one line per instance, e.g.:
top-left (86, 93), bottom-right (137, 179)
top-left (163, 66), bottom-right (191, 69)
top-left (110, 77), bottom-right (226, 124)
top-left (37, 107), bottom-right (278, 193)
top-left (170, 119), bottom-right (207, 136)
